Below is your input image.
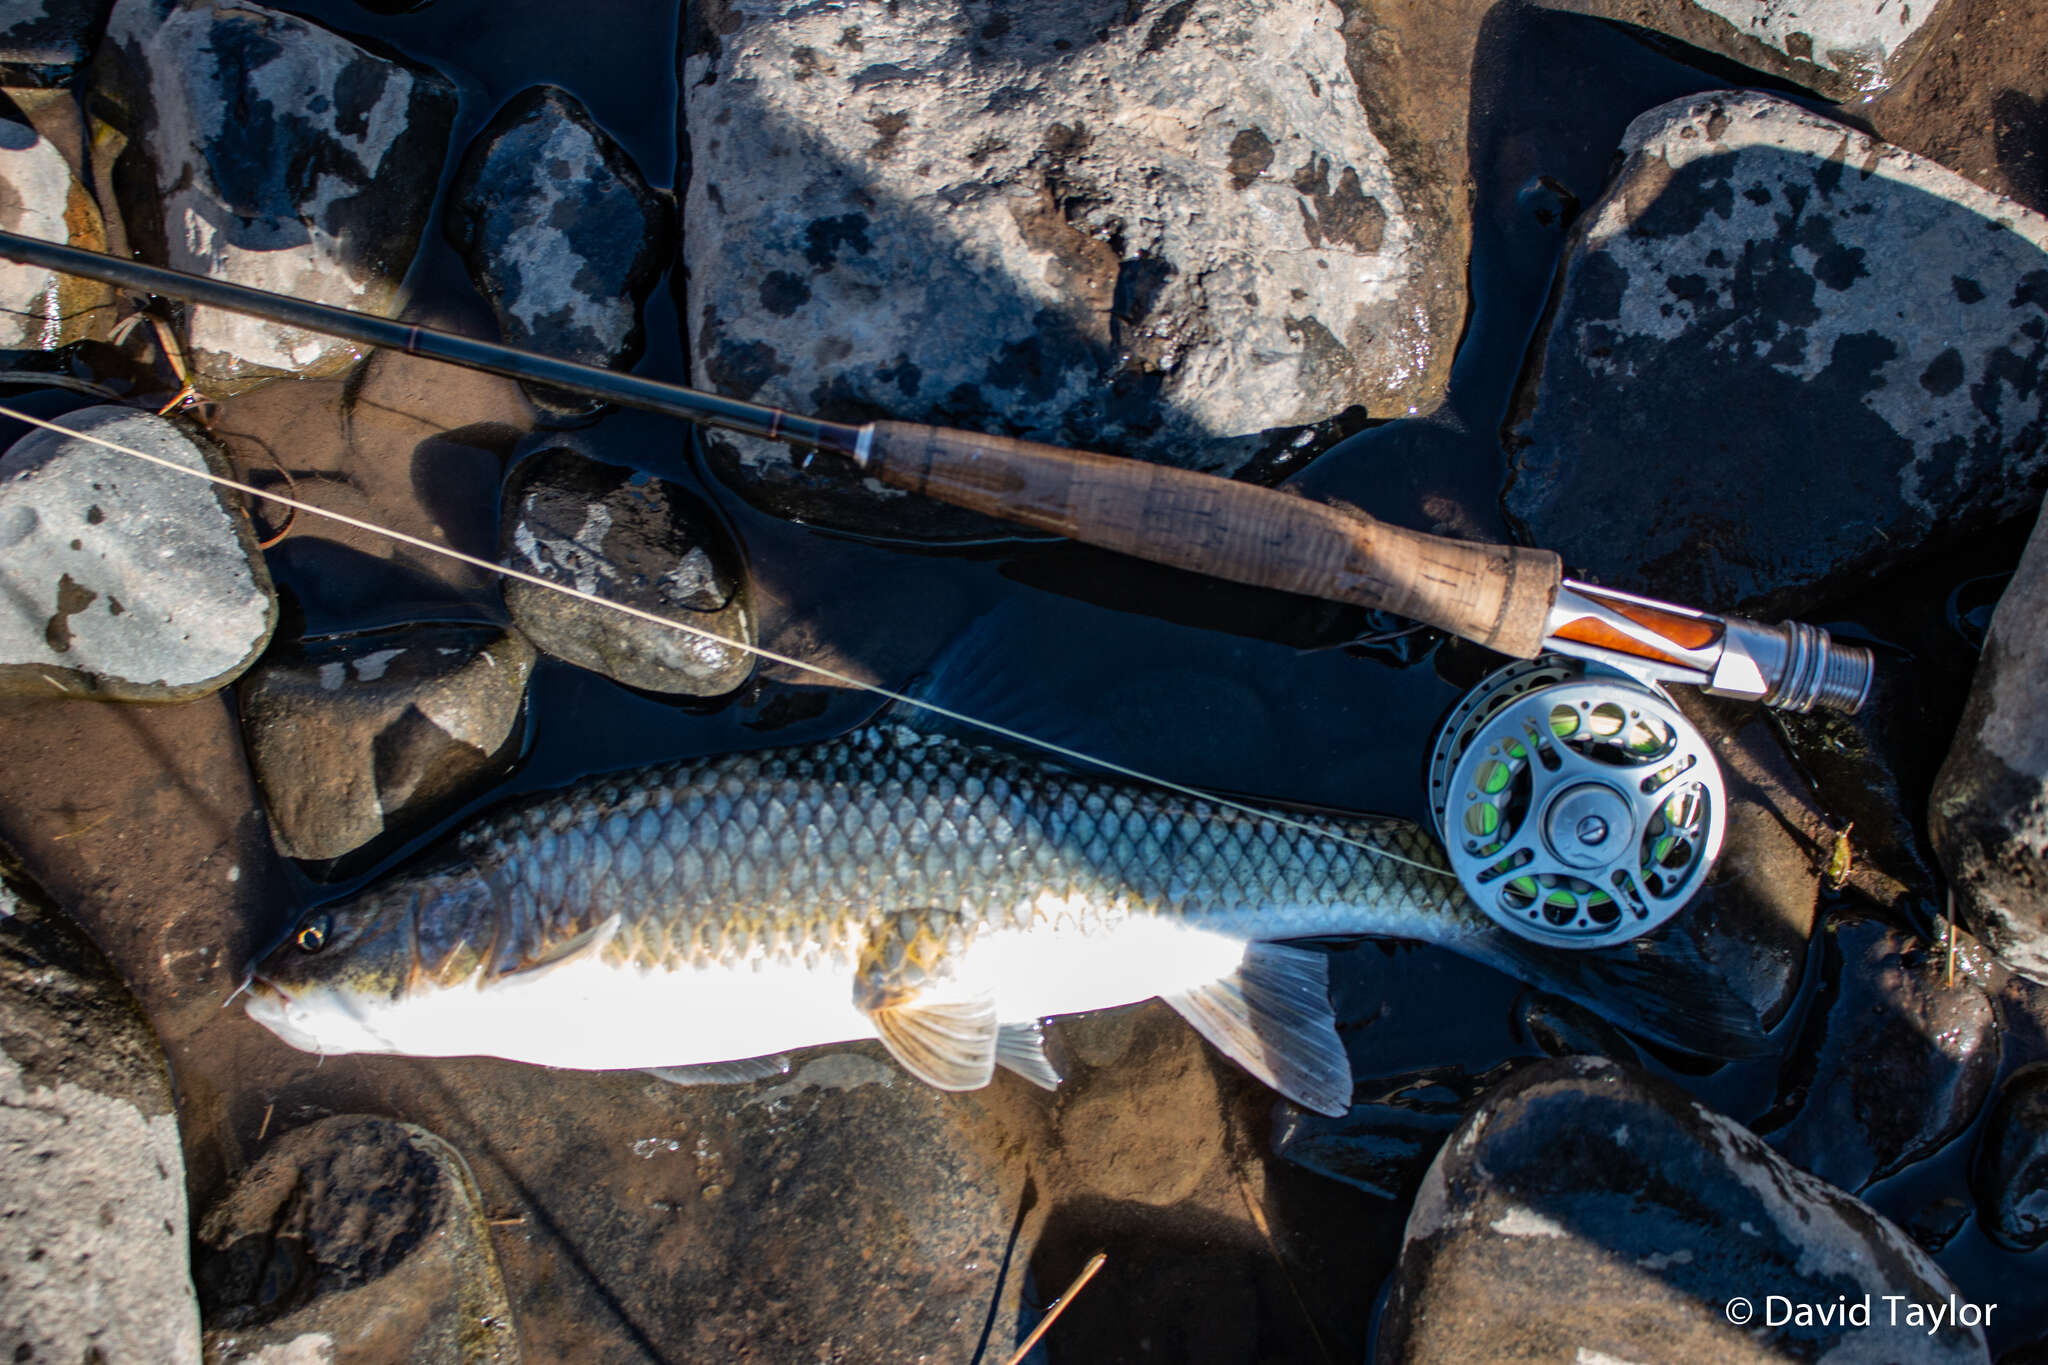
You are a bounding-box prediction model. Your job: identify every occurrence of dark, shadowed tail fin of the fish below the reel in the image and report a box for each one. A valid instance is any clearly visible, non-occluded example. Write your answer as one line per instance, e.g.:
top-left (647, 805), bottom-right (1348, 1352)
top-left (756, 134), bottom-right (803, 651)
top-left (1458, 929), bottom-right (1769, 1060)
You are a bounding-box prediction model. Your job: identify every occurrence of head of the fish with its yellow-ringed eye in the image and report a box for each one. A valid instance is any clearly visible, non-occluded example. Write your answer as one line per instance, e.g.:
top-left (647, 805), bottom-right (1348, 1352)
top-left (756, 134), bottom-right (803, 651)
top-left (244, 868), bottom-right (489, 1054)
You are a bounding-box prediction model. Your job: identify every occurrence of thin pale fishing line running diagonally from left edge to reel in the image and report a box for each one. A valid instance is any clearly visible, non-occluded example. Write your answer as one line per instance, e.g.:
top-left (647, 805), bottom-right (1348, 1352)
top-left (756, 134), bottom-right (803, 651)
top-left (0, 405), bottom-right (1456, 880)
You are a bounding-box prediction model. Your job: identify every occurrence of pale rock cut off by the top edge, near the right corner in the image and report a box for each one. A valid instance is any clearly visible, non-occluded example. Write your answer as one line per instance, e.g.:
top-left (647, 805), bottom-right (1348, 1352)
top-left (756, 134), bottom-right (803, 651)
top-left (1542, 0), bottom-right (1948, 100)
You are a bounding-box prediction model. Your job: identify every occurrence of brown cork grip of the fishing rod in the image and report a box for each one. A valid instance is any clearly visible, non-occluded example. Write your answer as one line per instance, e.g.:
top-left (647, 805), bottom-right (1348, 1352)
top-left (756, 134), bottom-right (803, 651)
top-left (854, 422), bottom-right (1563, 659)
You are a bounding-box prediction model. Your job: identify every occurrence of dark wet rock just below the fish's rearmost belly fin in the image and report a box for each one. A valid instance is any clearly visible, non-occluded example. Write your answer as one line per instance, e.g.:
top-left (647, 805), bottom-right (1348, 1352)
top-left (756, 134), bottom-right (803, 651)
top-left (1274, 1060), bottom-right (1528, 1203)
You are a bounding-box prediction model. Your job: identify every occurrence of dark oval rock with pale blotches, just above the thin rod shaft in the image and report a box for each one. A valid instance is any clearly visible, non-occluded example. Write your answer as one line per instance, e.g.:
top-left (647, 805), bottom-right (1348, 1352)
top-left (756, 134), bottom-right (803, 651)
top-left (446, 86), bottom-right (674, 417)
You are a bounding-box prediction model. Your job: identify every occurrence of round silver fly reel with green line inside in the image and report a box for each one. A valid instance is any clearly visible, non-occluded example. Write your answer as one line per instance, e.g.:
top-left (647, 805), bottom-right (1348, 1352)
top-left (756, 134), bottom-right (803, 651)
top-left (1430, 655), bottom-right (1726, 948)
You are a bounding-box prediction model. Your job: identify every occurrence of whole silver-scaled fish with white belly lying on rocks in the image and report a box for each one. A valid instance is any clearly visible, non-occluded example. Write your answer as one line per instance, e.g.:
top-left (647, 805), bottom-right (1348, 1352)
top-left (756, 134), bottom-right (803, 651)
top-left (244, 720), bottom-right (1761, 1115)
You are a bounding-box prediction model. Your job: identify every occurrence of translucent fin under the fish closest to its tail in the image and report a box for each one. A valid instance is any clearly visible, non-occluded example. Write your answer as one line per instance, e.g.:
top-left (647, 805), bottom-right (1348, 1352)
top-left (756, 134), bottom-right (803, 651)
top-left (1165, 943), bottom-right (1352, 1115)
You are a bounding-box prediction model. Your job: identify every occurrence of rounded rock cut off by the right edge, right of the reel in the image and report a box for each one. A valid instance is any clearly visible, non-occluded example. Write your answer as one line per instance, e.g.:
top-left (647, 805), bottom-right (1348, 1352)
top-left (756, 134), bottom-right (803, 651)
top-left (1927, 501), bottom-right (2048, 982)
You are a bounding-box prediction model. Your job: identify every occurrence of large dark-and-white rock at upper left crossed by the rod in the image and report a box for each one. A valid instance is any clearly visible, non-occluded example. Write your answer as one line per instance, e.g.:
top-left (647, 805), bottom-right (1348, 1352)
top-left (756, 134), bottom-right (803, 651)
top-left (90, 0), bottom-right (455, 397)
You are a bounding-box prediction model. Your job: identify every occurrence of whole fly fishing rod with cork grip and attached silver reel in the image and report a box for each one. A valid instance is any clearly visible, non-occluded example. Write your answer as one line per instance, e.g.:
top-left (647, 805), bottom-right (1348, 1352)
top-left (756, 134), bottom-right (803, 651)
top-left (0, 233), bottom-right (1874, 948)
